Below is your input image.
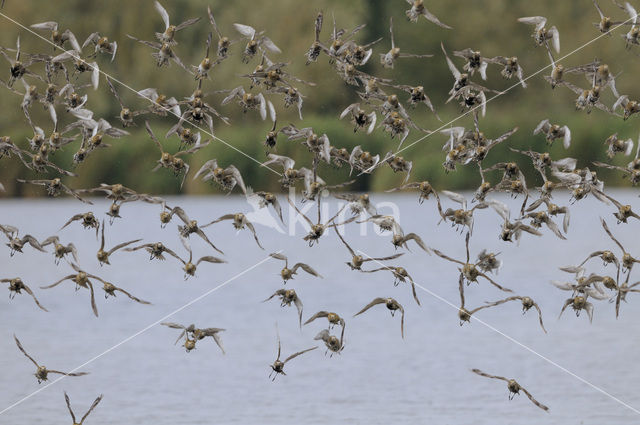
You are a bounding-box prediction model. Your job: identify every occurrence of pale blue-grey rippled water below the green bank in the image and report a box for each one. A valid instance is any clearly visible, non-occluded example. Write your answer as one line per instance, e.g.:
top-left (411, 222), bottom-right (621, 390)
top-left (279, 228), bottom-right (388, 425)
top-left (0, 191), bottom-right (640, 425)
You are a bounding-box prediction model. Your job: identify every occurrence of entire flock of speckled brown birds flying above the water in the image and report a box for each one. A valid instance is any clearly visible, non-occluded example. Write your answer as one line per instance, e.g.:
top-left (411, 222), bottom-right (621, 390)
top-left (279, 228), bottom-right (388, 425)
top-left (0, 0), bottom-right (640, 418)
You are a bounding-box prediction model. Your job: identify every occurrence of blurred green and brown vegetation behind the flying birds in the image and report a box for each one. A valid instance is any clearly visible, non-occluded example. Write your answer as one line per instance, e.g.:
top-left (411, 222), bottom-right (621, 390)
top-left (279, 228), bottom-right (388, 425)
top-left (0, 0), bottom-right (640, 196)
